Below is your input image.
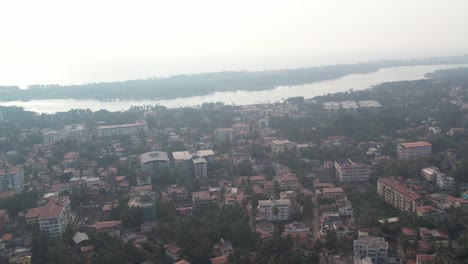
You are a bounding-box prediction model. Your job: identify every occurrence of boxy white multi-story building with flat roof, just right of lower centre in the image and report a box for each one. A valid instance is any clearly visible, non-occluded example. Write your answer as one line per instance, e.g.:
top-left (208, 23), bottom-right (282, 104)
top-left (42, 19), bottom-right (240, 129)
top-left (258, 199), bottom-right (291, 221)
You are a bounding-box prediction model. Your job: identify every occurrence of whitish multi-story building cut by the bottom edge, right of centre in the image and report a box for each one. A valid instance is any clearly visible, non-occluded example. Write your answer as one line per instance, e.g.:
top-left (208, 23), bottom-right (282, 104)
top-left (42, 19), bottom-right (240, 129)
top-left (353, 236), bottom-right (388, 264)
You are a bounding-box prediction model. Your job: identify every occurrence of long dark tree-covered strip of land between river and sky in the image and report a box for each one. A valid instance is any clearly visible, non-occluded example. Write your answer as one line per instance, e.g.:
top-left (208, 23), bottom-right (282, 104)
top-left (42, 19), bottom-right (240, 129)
top-left (0, 55), bottom-right (468, 101)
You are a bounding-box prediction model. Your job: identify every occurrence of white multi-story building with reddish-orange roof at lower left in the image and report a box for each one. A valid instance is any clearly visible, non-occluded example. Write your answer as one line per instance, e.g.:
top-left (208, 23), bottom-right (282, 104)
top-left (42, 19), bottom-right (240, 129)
top-left (26, 196), bottom-right (71, 237)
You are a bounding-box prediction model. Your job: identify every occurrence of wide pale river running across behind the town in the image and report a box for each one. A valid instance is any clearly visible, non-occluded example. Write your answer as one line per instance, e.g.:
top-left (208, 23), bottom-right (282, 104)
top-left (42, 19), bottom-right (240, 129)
top-left (0, 64), bottom-right (468, 113)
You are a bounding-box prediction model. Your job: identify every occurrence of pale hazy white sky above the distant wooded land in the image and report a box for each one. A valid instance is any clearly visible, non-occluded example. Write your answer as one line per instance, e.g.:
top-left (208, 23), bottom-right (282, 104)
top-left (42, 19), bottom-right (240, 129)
top-left (0, 0), bottom-right (468, 86)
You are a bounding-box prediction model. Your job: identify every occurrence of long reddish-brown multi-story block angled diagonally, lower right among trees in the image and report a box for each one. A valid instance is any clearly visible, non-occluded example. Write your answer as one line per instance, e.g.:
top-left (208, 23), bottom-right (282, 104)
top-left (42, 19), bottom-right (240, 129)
top-left (377, 177), bottom-right (423, 213)
